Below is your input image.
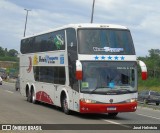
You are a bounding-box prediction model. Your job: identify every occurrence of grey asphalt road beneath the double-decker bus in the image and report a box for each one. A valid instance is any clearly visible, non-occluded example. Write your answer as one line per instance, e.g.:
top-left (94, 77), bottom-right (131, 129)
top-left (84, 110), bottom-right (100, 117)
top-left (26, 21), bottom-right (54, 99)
top-left (0, 83), bottom-right (160, 133)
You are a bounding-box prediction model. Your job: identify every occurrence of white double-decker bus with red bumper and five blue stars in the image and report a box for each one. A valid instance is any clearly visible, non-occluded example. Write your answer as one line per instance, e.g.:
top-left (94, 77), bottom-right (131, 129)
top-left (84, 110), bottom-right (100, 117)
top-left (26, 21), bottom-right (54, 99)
top-left (20, 24), bottom-right (147, 116)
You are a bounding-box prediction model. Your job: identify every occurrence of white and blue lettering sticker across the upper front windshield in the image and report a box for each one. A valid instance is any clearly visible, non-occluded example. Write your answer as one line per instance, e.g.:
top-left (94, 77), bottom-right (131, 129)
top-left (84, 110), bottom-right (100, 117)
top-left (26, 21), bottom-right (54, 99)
top-left (93, 47), bottom-right (124, 52)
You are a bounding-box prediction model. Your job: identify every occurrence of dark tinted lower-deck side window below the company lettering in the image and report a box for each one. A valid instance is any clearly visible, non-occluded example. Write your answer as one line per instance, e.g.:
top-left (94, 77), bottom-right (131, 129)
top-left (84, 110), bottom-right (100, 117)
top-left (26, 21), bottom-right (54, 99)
top-left (34, 66), bottom-right (66, 84)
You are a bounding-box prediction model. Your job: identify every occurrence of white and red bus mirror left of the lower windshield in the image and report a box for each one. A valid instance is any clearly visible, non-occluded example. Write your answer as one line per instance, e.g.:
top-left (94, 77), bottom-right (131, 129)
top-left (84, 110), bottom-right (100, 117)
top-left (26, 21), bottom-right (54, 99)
top-left (76, 60), bottom-right (82, 80)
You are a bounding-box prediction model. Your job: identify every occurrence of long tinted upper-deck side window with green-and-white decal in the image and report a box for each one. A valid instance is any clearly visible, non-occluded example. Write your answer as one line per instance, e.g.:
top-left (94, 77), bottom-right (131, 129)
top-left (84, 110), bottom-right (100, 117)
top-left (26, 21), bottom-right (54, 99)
top-left (21, 30), bottom-right (65, 54)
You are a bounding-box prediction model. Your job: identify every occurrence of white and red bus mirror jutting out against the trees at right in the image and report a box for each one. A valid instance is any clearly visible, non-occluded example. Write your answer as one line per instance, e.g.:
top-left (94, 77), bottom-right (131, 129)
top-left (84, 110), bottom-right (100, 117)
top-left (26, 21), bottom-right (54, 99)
top-left (138, 60), bottom-right (147, 80)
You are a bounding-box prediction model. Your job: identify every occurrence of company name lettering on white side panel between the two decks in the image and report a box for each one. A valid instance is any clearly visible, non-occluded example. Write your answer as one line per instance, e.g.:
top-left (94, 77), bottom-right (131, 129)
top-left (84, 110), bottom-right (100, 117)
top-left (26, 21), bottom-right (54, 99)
top-left (39, 55), bottom-right (58, 64)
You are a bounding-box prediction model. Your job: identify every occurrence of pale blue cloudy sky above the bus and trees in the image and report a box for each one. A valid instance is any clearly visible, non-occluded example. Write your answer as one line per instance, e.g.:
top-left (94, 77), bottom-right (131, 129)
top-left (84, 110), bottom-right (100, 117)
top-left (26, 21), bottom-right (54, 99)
top-left (0, 0), bottom-right (160, 56)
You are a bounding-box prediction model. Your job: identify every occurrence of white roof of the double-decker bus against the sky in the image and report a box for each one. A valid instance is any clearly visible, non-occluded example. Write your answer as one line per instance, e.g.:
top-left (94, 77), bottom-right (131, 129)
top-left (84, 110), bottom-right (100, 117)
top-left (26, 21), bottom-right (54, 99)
top-left (22, 23), bottom-right (128, 39)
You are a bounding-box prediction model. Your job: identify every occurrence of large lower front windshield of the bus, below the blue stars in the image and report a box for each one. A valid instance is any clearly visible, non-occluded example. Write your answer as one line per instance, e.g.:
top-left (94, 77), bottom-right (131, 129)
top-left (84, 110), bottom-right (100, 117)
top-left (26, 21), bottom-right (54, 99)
top-left (81, 62), bottom-right (137, 94)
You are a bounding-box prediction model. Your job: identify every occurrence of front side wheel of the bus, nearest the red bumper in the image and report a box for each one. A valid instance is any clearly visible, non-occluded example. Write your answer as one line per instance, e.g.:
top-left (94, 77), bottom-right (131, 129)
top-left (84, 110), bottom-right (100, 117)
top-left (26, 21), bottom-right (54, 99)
top-left (62, 95), bottom-right (70, 115)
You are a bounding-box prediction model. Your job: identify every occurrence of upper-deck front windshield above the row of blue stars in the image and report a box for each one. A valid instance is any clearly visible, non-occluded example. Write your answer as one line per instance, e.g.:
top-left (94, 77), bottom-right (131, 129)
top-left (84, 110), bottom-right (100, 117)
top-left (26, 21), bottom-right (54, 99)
top-left (78, 29), bottom-right (135, 55)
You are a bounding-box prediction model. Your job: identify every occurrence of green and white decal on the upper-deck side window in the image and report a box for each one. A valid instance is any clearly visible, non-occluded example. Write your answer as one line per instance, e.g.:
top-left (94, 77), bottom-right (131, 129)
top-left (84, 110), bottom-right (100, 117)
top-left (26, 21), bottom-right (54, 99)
top-left (54, 35), bottom-right (64, 49)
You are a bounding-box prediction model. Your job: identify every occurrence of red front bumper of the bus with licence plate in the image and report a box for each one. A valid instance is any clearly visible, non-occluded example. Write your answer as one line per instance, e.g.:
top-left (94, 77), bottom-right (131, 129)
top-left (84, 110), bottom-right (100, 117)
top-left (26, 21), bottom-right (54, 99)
top-left (80, 101), bottom-right (137, 113)
